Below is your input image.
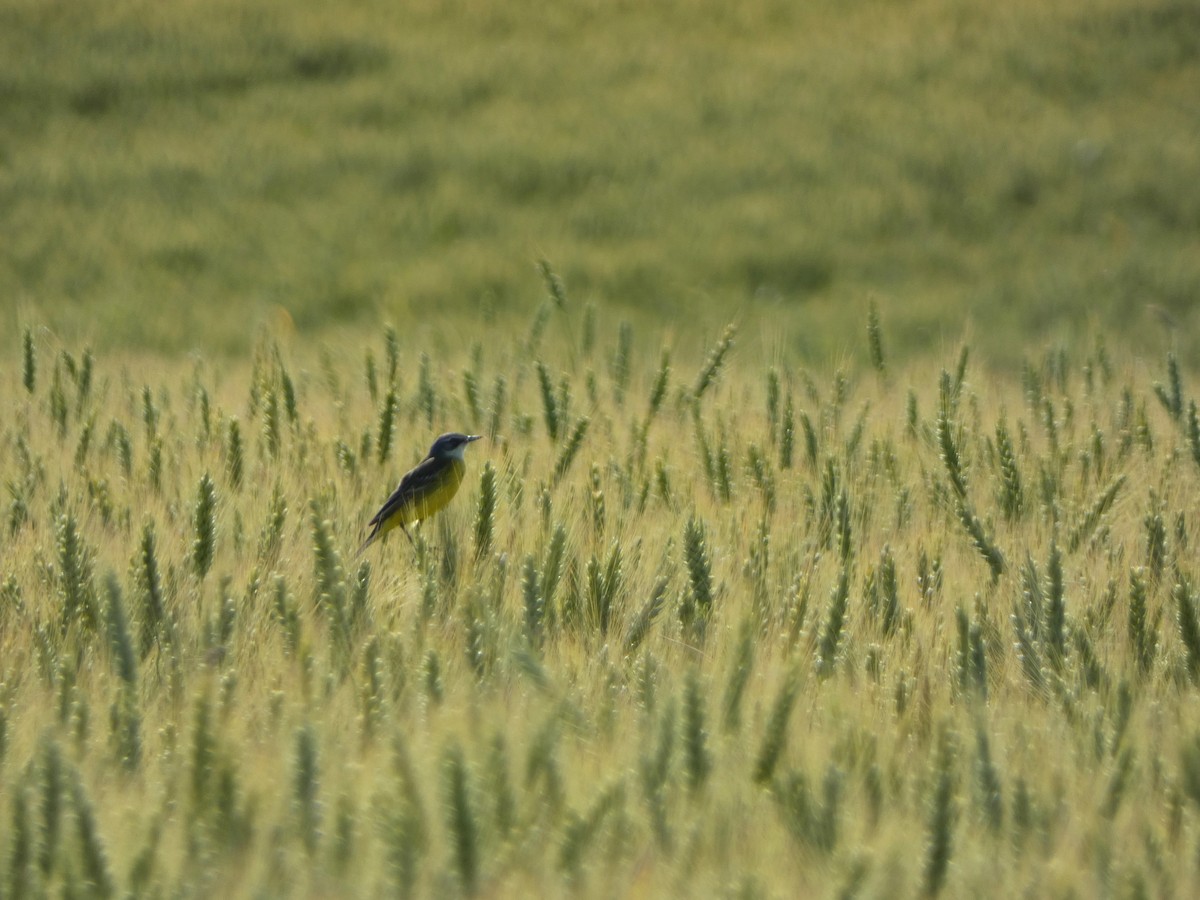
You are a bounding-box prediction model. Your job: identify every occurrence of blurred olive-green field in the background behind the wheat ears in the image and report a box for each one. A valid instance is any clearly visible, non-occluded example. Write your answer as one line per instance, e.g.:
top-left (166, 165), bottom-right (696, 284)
top-left (0, 0), bottom-right (1200, 365)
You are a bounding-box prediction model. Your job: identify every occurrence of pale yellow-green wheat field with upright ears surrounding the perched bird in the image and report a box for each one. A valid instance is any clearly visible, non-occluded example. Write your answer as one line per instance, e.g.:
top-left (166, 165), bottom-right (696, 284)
top-left (0, 297), bottom-right (1200, 898)
